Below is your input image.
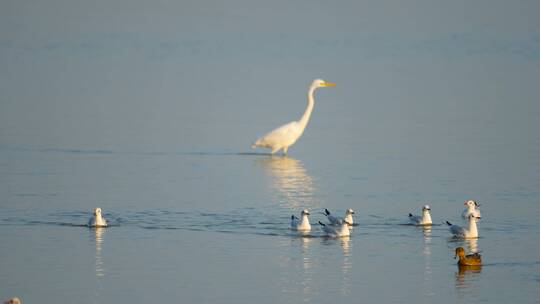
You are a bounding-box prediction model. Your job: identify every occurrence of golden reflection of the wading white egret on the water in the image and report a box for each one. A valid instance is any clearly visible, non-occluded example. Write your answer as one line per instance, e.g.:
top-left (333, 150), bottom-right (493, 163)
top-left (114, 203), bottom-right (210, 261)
top-left (256, 156), bottom-right (316, 209)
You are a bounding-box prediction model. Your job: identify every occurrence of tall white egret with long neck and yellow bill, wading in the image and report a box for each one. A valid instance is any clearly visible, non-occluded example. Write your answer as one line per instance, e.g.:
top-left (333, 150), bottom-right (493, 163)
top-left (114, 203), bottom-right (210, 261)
top-left (251, 79), bottom-right (336, 154)
